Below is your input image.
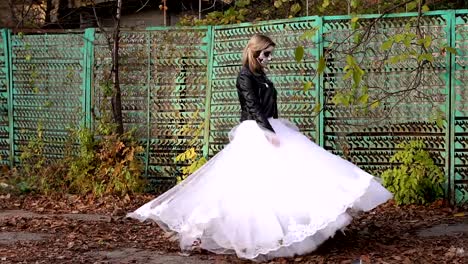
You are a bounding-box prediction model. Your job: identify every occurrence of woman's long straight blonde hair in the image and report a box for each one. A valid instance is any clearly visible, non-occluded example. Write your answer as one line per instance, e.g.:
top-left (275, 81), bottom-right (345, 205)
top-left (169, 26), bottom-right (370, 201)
top-left (242, 34), bottom-right (276, 73)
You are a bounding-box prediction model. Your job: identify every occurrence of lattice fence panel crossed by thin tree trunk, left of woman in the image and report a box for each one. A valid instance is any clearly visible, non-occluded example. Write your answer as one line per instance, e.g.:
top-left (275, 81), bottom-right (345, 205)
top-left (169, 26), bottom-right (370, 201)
top-left (93, 29), bottom-right (211, 188)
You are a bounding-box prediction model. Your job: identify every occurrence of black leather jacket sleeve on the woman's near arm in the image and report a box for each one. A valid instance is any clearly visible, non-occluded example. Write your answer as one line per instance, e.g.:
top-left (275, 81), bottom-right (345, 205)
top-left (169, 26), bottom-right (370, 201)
top-left (238, 73), bottom-right (275, 133)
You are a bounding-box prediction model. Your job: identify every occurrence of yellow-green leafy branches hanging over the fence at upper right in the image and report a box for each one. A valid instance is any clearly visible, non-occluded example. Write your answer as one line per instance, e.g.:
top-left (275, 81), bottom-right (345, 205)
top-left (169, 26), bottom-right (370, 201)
top-left (294, 0), bottom-right (457, 121)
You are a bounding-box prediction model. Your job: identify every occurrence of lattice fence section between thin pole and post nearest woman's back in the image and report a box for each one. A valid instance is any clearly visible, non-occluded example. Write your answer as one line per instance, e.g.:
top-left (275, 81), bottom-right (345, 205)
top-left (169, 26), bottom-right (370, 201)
top-left (148, 28), bottom-right (211, 189)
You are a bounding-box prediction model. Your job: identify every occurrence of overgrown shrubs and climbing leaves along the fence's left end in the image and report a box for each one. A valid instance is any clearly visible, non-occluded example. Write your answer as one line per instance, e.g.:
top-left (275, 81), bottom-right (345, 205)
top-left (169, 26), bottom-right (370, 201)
top-left (0, 35), bottom-right (145, 196)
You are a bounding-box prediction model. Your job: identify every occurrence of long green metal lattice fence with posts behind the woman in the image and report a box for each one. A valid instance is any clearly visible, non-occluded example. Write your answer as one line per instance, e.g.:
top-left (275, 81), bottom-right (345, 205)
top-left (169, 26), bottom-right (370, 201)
top-left (0, 10), bottom-right (468, 204)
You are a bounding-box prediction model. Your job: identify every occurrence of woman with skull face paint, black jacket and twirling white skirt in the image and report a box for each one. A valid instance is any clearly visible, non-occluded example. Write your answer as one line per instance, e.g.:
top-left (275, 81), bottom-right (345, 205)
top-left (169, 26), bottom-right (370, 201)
top-left (129, 35), bottom-right (392, 260)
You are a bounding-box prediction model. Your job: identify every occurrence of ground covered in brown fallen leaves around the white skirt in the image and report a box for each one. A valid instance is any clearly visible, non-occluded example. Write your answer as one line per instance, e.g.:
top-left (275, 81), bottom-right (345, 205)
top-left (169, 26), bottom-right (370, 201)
top-left (0, 194), bottom-right (468, 264)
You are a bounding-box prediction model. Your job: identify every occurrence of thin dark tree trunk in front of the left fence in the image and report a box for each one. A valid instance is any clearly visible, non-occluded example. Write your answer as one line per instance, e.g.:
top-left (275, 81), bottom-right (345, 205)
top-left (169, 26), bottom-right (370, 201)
top-left (112, 0), bottom-right (124, 135)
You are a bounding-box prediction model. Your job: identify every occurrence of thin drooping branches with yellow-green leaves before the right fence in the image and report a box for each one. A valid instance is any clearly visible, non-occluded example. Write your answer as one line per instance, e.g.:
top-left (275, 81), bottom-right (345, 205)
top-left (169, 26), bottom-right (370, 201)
top-left (295, 0), bottom-right (457, 124)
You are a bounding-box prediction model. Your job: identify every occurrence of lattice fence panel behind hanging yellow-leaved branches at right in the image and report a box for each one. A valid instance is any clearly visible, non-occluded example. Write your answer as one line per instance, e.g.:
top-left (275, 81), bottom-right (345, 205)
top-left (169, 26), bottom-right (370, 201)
top-left (323, 15), bottom-right (450, 179)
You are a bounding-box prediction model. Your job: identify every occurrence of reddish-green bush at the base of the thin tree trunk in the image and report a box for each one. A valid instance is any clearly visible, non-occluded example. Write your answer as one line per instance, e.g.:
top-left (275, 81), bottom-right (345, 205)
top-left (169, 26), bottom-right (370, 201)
top-left (67, 128), bottom-right (144, 196)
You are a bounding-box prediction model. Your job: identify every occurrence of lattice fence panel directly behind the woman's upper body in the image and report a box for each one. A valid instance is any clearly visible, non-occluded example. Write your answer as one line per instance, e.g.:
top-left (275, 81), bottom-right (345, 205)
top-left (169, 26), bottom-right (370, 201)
top-left (209, 18), bottom-right (318, 156)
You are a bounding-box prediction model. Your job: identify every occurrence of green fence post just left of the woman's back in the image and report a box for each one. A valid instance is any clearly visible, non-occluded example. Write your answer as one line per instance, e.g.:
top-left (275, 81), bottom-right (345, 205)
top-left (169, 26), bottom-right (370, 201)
top-left (203, 26), bottom-right (215, 157)
